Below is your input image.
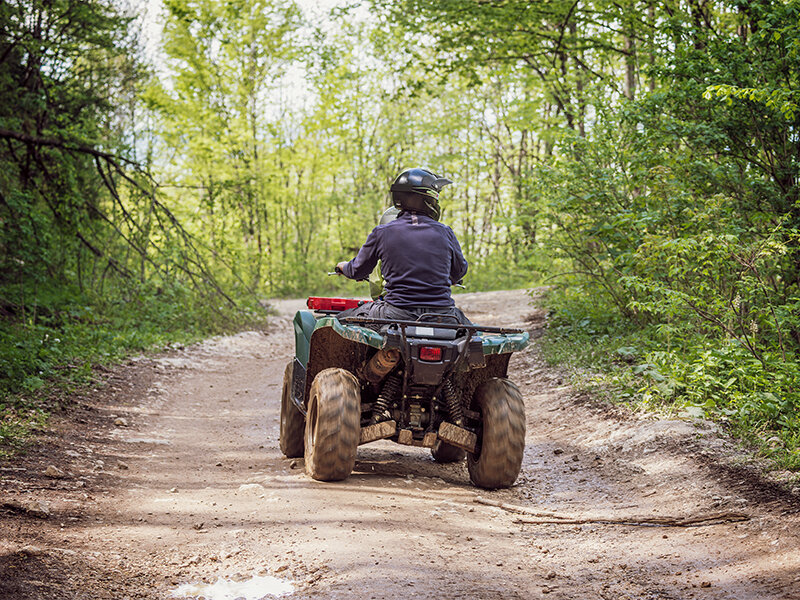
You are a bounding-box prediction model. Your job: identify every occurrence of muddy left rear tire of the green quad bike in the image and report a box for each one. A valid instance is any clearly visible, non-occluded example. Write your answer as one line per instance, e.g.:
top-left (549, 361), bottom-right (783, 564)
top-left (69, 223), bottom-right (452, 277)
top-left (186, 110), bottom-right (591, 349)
top-left (305, 369), bottom-right (361, 481)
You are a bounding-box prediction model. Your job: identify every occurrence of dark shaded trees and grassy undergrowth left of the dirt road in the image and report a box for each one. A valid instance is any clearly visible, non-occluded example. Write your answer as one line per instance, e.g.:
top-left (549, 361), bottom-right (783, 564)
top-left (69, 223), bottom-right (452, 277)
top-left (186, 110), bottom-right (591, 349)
top-left (0, 0), bottom-right (268, 448)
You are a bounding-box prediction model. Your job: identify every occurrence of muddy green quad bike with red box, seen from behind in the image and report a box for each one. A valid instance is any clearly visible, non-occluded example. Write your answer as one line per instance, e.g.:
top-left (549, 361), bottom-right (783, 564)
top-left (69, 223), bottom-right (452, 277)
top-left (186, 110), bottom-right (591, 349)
top-left (280, 297), bottom-right (528, 489)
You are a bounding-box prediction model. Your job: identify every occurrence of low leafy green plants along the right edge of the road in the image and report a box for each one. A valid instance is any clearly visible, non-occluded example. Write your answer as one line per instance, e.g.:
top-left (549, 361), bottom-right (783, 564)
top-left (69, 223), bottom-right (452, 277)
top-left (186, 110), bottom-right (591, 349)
top-left (537, 288), bottom-right (800, 481)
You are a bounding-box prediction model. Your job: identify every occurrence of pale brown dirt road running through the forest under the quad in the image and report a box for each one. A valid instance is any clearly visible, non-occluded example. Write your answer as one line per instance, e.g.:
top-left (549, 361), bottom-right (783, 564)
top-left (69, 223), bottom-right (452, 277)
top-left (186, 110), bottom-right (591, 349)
top-left (0, 292), bottom-right (800, 600)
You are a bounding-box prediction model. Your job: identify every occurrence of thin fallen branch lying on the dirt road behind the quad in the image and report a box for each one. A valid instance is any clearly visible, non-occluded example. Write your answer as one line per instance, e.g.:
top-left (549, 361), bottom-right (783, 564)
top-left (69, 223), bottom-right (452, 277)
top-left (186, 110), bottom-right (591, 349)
top-left (475, 496), bottom-right (750, 527)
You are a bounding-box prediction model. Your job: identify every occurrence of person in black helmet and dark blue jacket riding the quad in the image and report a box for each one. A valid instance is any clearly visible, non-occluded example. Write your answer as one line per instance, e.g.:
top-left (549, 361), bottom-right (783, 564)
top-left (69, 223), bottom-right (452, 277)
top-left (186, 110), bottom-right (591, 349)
top-left (336, 168), bottom-right (469, 324)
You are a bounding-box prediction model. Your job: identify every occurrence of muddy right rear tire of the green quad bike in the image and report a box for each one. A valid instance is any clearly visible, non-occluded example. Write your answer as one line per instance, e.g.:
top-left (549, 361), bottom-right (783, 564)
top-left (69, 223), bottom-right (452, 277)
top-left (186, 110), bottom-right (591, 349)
top-left (467, 378), bottom-right (525, 490)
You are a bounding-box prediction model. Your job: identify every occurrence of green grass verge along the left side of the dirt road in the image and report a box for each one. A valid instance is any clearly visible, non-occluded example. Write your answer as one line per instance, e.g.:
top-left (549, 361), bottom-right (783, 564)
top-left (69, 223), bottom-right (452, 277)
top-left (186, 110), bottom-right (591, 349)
top-left (0, 289), bottom-right (267, 458)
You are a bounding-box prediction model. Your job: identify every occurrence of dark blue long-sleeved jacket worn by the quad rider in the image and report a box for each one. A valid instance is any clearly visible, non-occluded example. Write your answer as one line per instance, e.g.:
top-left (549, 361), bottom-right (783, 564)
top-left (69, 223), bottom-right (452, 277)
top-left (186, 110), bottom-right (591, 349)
top-left (342, 211), bottom-right (467, 306)
